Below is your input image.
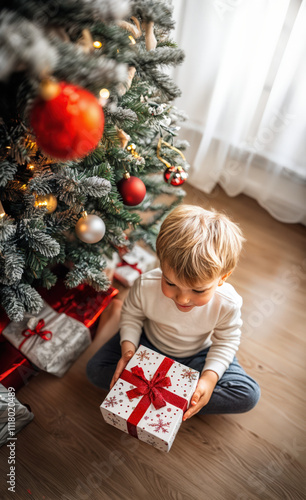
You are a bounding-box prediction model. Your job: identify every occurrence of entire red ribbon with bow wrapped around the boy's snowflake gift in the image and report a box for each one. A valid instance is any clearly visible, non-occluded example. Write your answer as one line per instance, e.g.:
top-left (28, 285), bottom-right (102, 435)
top-left (120, 358), bottom-right (188, 438)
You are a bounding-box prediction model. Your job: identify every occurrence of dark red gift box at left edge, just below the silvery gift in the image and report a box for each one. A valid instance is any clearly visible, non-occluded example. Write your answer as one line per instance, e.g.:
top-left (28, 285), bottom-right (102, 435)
top-left (0, 335), bottom-right (39, 391)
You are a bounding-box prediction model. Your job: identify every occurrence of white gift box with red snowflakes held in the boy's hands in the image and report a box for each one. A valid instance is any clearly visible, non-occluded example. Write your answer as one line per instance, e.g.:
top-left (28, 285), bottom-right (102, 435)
top-left (100, 345), bottom-right (200, 452)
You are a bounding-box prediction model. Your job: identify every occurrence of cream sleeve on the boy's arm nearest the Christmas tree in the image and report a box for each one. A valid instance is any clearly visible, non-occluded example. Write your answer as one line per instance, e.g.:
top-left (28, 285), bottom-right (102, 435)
top-left (119, 278), bottom-right (146, 350)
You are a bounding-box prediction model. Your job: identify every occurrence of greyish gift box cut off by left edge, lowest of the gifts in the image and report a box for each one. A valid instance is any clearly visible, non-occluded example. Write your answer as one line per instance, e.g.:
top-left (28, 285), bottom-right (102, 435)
top-left (0, 384), bottom-right (34, 448)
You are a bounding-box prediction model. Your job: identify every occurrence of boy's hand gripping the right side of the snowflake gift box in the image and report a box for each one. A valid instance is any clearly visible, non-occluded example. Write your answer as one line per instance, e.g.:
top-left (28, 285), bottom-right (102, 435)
top-left (183, 370), bottom-right (218, 422)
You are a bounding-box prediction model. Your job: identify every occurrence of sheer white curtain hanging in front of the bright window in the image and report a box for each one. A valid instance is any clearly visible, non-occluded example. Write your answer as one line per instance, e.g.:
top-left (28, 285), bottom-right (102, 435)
top-left (173, 0), bottom-right (306, 224)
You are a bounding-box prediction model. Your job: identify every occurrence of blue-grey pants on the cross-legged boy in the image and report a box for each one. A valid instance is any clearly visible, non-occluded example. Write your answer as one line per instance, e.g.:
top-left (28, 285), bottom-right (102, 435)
top-left (86, 330), bottom-right (260, 415)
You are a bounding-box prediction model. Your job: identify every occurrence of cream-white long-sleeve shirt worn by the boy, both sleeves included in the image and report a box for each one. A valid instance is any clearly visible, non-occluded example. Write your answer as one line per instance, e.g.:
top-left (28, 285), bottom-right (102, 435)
top-left (120, 268), bottom-right (242, 379)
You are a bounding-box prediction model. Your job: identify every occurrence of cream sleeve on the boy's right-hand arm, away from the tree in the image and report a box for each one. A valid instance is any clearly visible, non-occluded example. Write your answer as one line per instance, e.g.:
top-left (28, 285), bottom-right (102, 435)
top-left (202, 300), bottom-right (242, 379)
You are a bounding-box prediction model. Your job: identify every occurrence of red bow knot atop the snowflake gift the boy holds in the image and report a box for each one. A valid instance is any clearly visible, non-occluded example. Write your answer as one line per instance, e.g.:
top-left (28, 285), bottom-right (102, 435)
top-left (127, 366), bottom-right (171, 410)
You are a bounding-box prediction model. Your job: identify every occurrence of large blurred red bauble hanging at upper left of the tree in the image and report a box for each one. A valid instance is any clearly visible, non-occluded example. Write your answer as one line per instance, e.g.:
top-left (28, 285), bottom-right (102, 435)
top-left (30, 82), bottom-right (104, 160)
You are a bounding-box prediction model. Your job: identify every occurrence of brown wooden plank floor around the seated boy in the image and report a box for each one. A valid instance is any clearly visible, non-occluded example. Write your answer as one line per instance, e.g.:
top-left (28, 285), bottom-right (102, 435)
top-left (0, 186), bottom-right (306, 500)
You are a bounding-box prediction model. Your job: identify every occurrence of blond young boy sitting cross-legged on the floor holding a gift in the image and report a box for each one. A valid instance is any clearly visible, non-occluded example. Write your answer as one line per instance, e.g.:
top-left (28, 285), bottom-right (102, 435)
top-left (87, 205), bottom-right (260, 420)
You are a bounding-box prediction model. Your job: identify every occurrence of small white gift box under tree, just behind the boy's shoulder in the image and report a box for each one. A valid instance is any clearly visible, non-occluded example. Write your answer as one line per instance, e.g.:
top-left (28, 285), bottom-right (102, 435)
top-left (114, 245), bottom-right (158, 287)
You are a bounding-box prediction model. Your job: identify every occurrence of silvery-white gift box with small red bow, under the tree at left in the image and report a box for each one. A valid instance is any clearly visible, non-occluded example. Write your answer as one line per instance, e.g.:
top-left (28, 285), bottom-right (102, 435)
top-left (2, 302), bottom-right (91, 377)
